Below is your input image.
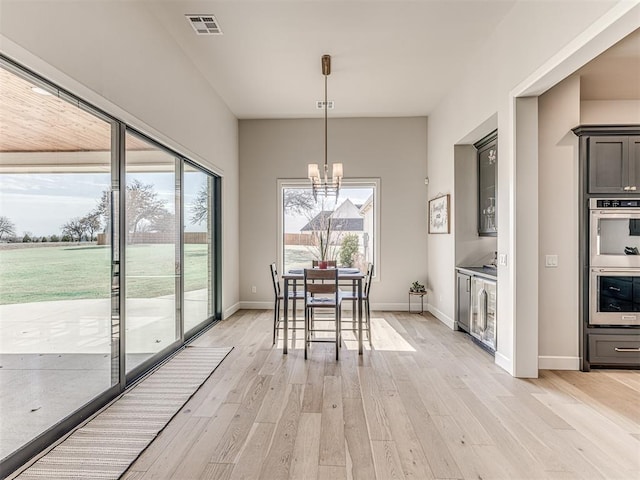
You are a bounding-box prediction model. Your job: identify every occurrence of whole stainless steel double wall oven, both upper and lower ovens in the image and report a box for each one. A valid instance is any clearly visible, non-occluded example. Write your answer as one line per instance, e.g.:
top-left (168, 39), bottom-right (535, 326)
top-left (589, 198), bottom-right (640, 326)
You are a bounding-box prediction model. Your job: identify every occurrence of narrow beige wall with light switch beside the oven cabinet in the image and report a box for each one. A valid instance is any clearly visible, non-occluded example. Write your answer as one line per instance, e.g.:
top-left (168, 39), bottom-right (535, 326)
top-left (538, 75), bottom-right (580, 369)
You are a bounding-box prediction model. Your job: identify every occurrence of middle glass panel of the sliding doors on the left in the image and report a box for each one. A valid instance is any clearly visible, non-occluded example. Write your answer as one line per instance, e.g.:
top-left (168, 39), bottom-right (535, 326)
top-left (123, 133), bottom-right (181, 373)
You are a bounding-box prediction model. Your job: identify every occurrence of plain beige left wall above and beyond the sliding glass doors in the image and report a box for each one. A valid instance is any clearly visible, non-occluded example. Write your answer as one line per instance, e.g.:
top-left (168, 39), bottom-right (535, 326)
top-left (0, 0), bottom-right (239, 315)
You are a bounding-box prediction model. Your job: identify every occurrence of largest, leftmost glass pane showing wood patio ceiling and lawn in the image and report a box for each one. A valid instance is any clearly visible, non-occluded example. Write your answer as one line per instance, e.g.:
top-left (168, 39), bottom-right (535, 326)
top-left (0, 63), bottom-right (118, 458)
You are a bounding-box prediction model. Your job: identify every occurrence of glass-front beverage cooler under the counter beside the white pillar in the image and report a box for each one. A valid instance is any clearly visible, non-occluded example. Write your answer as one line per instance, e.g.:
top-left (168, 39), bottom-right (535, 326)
top-left (469, 276), bottom-right (497, 352)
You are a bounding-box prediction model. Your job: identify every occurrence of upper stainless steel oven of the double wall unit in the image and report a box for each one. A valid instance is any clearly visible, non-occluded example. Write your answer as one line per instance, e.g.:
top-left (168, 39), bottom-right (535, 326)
top-left (589, 198), bottom-right (640, 268)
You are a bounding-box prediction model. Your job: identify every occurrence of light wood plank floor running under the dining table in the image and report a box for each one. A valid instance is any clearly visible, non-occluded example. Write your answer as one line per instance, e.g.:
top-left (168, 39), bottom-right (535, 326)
top-left (123, 310), bottom-right (640, 480)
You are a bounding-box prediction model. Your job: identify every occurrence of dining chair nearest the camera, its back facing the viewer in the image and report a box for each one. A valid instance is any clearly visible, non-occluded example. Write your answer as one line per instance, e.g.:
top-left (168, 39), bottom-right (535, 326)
top-left (304, 268), bottom-right (342, 360)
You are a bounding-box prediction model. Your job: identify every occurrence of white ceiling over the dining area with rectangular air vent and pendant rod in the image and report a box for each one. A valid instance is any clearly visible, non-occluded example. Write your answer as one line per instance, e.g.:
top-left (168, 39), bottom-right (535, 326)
top-left (146, 0), bottom-right (516, 119)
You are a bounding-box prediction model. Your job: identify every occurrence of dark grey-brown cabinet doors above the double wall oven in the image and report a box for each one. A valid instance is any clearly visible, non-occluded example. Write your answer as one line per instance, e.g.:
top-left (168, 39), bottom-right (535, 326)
top-left (587, 135), bottom-right (640, 194)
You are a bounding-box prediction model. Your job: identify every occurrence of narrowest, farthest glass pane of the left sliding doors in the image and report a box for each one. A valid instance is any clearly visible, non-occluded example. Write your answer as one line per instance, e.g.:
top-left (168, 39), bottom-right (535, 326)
top-left (183, 163), bottom-right (214, 332)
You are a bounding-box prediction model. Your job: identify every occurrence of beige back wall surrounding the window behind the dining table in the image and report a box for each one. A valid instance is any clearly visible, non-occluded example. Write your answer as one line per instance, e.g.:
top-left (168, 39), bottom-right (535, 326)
top-left (240, 117), bottom-right (428, 310)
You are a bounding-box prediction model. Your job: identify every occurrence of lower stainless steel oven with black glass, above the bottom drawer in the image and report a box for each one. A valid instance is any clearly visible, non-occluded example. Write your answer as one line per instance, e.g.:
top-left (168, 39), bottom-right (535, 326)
top-left (589, 267), bottom-right (640, 326)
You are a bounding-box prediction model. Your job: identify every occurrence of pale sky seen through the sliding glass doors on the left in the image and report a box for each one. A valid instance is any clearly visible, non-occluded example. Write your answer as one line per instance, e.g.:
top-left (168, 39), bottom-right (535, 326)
top-left (0, 172), bottom-right (205, 237)
